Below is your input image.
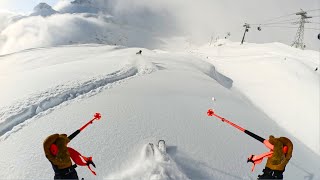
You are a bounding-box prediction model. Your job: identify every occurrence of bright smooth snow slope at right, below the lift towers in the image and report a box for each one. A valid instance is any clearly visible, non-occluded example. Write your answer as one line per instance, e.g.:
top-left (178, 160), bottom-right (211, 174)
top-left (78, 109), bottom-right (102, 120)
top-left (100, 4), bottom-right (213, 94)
top-left (194, 40), bottom-right (320, 154)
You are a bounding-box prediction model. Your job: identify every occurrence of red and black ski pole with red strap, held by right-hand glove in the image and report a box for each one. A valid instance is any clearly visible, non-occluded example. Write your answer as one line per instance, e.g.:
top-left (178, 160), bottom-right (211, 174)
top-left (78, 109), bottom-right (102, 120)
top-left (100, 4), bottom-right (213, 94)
top-left (207, 109), bottom-right (288, 170)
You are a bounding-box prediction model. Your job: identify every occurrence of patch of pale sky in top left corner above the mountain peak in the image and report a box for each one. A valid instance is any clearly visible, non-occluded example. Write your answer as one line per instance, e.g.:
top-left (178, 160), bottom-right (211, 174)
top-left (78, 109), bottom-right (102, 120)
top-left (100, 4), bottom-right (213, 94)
top-left (0, 0), bottom-right (58, 12)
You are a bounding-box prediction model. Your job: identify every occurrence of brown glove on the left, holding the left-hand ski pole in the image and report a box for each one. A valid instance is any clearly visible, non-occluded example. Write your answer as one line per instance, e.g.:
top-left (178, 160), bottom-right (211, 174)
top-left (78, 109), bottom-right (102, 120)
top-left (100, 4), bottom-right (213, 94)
top-left (43, 134), bottom-right (72, 169)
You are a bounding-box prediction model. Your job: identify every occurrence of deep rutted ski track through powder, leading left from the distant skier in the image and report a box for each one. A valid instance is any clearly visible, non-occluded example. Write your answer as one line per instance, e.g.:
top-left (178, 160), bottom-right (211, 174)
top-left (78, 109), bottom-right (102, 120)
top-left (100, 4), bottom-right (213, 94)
top-left (0, 60), bottom-right (157, 141)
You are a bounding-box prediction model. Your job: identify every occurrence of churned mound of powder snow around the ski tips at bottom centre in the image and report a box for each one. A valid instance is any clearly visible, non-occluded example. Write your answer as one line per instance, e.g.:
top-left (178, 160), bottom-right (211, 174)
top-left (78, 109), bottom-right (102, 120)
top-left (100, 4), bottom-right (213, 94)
top-left (105, 145), bottom-right (189, 180)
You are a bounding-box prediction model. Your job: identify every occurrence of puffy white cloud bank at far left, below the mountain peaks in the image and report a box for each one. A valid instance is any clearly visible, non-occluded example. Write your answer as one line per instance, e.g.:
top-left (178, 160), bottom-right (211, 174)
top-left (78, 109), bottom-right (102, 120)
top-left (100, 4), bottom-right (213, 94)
top-left (0, 14), bottom-right (111, 54)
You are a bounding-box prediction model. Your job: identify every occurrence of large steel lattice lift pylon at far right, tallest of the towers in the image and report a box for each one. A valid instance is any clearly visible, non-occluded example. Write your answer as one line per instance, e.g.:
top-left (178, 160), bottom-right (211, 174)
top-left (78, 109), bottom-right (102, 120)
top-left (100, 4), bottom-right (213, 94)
top-left (291, 9), bottom-right (312, 49)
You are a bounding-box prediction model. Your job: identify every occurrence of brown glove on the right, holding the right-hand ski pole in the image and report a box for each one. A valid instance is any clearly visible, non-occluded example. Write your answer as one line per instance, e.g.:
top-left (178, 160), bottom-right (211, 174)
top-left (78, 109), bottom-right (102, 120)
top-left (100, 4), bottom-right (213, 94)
top-left (266, 135), bottom-right (293, 171)
